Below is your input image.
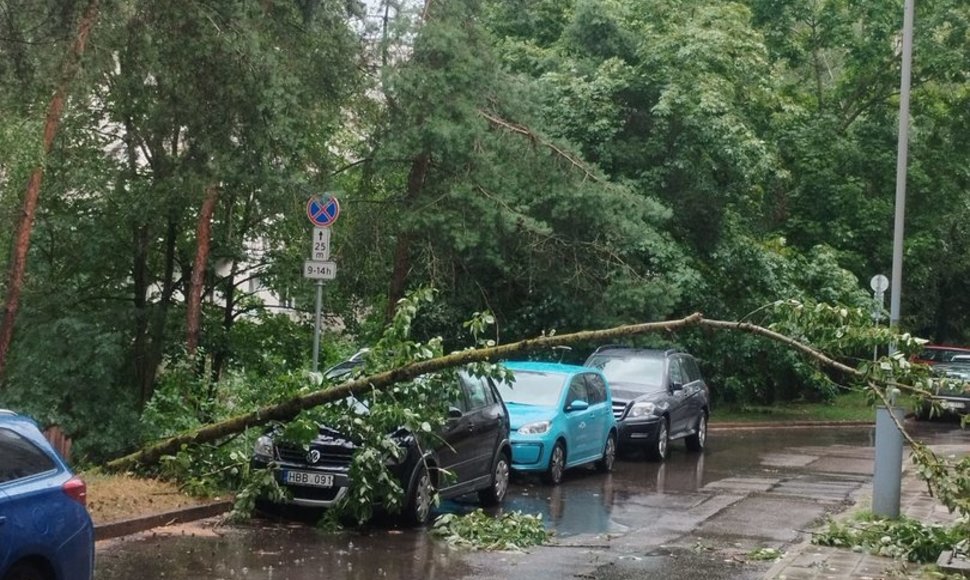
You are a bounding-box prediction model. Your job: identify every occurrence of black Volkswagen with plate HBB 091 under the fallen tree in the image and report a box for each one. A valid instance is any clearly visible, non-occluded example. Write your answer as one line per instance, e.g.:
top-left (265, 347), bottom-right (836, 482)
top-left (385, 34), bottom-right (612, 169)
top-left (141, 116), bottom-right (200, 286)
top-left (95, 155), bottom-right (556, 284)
top-left (252, 373), bottom-right (512, 525)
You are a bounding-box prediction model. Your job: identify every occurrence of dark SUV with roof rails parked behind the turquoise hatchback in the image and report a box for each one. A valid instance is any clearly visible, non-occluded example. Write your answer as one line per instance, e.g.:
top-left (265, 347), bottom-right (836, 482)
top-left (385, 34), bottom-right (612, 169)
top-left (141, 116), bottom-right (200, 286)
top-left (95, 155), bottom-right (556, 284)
top-left (586, 346), bottom-right (710, 461)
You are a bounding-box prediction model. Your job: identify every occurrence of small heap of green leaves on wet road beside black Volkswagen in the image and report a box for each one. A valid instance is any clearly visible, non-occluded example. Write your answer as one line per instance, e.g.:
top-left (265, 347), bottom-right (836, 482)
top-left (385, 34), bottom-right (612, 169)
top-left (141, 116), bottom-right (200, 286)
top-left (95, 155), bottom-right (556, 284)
top-left (431, 509), bottom-right (551, 551)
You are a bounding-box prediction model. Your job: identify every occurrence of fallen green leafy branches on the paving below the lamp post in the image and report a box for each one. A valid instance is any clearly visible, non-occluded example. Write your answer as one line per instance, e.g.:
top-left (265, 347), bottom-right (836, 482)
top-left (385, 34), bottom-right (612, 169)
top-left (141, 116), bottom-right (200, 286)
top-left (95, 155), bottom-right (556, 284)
top-left (812, 514), bottom-right (970, 562)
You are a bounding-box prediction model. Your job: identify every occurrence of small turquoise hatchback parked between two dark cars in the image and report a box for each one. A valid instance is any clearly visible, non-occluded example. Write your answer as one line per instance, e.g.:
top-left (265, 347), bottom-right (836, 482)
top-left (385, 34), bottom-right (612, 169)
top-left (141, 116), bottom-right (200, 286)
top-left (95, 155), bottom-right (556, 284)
top-left (498, 362), bottom-right (616, 485)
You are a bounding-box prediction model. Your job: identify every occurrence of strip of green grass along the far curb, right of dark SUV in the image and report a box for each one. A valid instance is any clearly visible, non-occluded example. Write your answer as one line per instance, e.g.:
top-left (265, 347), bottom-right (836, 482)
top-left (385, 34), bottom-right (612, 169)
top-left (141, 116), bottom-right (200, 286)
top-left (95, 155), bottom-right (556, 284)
top-left (711, 391), bottom-right (876, 424)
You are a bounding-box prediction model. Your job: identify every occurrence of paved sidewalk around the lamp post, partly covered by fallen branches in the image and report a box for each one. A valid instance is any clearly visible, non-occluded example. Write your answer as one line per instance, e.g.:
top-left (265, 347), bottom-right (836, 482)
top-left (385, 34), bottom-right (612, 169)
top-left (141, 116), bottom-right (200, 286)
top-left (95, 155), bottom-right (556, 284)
top-left (765, 445), bottom-right (970, 580)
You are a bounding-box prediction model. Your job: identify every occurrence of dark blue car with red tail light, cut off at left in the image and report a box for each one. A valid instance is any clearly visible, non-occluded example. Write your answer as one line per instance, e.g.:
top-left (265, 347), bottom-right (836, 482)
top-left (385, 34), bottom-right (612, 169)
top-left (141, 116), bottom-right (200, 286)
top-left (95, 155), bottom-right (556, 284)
top-left (0, 409), bottom-right (94, 580)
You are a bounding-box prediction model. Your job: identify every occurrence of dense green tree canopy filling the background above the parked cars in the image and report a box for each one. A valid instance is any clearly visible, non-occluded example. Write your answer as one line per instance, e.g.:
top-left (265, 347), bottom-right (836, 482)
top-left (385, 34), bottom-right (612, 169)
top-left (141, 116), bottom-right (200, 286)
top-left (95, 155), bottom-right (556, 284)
top-left (0, 0), bottom-right (970, 459)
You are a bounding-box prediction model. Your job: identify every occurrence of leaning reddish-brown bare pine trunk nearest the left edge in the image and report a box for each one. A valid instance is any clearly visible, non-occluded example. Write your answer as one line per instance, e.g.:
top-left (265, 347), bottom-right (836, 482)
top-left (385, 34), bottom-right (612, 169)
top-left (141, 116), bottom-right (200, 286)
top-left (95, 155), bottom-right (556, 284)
top-left (0, 0), bottom-right (98, 385)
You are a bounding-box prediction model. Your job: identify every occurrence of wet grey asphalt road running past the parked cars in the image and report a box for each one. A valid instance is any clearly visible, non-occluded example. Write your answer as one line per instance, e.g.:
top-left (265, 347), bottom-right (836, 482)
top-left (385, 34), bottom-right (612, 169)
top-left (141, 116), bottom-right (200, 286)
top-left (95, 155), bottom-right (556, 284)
top-left (96, 424), bottom-right (970, 580)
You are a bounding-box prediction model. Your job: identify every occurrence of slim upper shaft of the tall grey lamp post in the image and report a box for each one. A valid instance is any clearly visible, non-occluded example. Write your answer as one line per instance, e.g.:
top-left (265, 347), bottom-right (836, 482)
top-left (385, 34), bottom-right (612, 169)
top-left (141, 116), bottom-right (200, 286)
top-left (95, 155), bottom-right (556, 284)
top-left (889, 0), bottom-right (916, 340)
